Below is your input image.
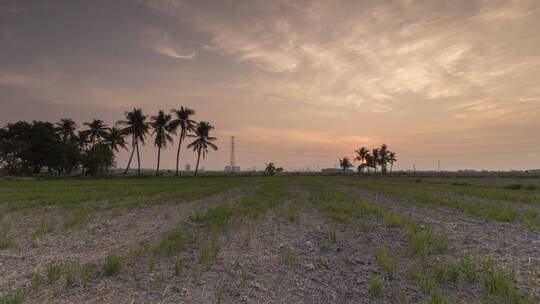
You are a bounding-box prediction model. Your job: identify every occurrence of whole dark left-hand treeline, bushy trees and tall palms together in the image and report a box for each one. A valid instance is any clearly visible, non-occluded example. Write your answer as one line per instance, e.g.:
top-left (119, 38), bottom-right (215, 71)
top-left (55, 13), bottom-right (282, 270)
top-left (0, 106), bottom-right (218, 175)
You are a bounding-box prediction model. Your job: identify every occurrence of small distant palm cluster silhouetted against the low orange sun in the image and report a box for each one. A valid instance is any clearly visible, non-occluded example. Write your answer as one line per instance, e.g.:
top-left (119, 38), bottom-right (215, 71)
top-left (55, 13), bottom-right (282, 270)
top-left (339, 144), bottom-right (397, 174)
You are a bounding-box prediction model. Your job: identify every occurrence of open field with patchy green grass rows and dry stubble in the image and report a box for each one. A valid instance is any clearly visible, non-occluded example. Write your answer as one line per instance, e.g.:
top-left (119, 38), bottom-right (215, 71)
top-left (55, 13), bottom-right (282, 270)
top-left (0, 176), bottom-right (540, 304)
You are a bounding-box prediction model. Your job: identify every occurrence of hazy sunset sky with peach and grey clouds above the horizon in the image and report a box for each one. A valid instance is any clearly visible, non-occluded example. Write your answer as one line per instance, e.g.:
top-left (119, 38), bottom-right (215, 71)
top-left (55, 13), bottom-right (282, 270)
top-left (0, 0), bottom-right (540, 170)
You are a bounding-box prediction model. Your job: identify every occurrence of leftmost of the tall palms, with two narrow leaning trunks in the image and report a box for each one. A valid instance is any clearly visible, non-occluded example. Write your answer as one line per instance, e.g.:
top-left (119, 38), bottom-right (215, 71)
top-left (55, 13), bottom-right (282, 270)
top-left (118, 108), bottom-right (150, 174)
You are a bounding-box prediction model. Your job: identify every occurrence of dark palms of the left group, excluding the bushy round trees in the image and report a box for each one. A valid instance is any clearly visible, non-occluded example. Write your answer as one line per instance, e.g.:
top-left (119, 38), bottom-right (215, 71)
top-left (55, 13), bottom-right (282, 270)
top-left (56, 106), bottom-right (218, 176)
